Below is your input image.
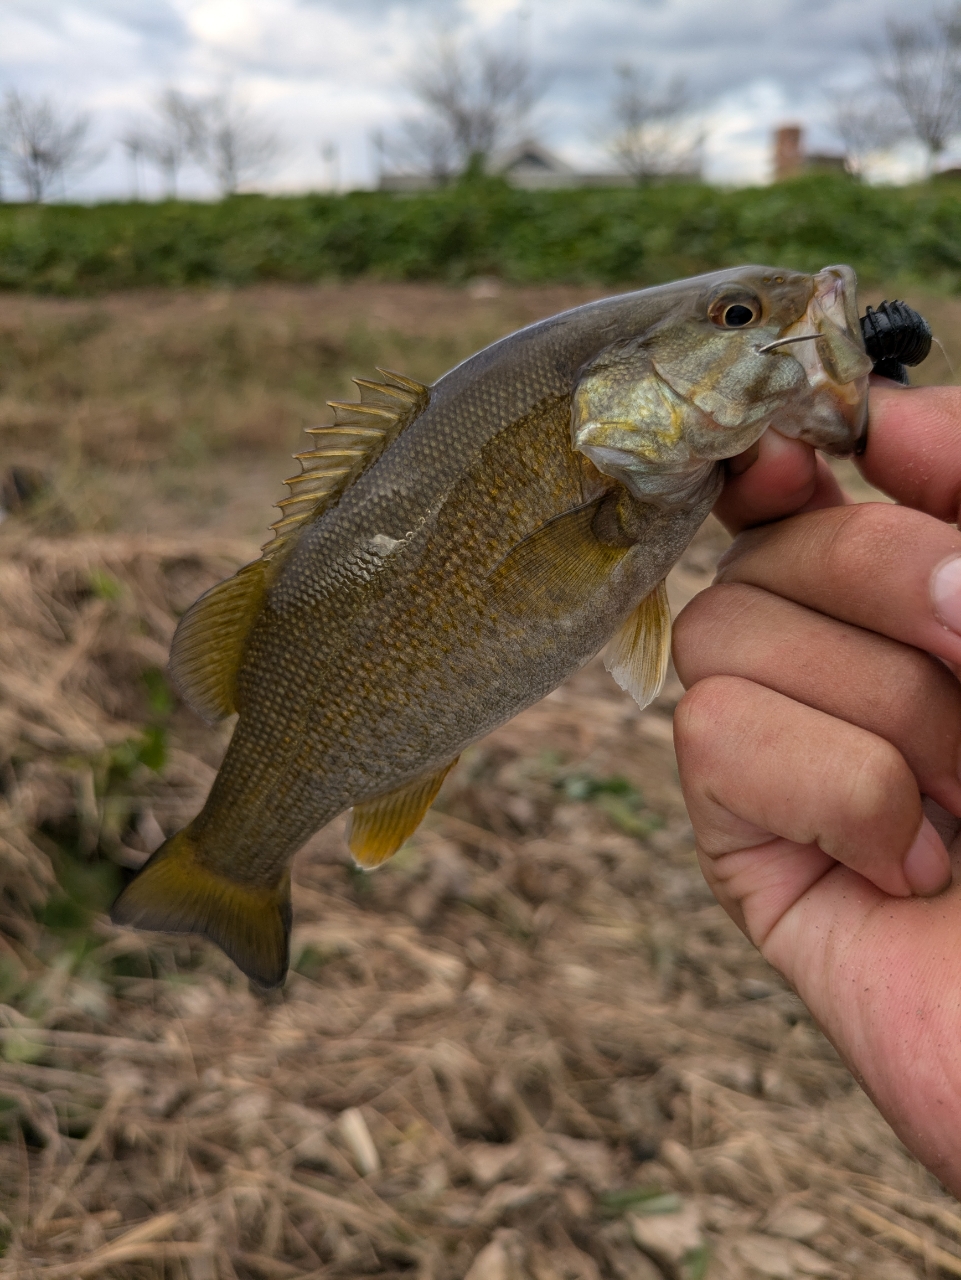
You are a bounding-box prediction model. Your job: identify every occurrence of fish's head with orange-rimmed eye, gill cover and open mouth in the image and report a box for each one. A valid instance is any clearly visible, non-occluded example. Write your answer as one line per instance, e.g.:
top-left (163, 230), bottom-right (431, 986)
top-left (572, 266), bottom-right (871, 495)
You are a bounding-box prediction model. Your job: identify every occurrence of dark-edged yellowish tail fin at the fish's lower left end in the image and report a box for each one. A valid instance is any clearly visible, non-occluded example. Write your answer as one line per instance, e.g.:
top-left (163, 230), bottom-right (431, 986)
top-left (110, 827), bottom-right (290, 987)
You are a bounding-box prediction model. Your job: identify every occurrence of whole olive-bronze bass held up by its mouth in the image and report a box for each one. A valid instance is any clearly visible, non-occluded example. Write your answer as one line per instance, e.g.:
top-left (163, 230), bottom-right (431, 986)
top-left (111, 259), bottom-right (871, 988)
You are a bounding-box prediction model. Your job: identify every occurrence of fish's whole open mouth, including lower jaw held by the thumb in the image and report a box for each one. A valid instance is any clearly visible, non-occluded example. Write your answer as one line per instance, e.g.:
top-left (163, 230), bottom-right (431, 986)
top-left (758, 265), bottom-right (873, 454)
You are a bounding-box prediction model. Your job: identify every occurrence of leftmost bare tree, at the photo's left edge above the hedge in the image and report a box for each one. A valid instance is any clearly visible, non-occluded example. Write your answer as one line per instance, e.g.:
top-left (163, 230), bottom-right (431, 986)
top-left (0, 90), bottom-right (100, 202)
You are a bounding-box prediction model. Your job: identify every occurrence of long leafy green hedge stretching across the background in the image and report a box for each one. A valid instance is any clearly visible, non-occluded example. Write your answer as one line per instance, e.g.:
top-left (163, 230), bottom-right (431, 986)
top-left (0, 177), bottom-right (961, 293)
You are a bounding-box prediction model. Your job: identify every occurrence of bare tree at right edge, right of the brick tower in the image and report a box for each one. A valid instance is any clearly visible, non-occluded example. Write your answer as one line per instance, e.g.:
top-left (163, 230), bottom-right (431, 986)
top-left (874, 5), bottom-right (961, 174)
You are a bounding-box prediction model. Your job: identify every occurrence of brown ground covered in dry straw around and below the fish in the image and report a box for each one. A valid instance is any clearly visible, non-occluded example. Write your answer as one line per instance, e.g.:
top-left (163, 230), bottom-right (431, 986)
top-left (0, 282), bottom-right (961, 1280)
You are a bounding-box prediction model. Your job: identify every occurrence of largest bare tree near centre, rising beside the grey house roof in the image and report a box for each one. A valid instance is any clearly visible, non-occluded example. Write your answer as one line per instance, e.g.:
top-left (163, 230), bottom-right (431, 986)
top-left (390, 32), bottom-right (545, 183)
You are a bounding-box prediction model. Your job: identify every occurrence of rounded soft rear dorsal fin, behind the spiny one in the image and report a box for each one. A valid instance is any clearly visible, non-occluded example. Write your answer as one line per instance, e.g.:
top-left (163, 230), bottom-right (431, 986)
top-left (170, 561), bottom-right (267, 722)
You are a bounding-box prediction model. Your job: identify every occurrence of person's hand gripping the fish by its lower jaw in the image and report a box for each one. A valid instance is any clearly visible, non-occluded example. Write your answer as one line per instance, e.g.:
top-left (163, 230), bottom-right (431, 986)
top-left (674, 384), bottom-right (961, 1194)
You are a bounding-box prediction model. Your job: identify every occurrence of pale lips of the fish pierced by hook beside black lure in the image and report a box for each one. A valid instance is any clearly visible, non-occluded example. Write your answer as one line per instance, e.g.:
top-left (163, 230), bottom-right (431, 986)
top-left (772, 265), bottom-right (871, 452)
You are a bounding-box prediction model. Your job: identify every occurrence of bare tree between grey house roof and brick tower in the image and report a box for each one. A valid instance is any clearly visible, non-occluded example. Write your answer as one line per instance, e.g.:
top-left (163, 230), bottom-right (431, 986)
top-left (609, 64), bottom-right (704, 183)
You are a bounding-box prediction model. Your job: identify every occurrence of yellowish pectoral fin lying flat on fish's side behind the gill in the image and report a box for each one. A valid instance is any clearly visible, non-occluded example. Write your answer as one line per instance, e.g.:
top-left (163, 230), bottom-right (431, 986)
top-left (488, 498), bottom-right (628, 614)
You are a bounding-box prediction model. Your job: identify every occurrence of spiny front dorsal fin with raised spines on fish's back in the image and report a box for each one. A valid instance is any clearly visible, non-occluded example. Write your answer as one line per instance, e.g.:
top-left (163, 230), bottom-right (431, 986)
top-left (264, 369), bottom-right (430, 559)
